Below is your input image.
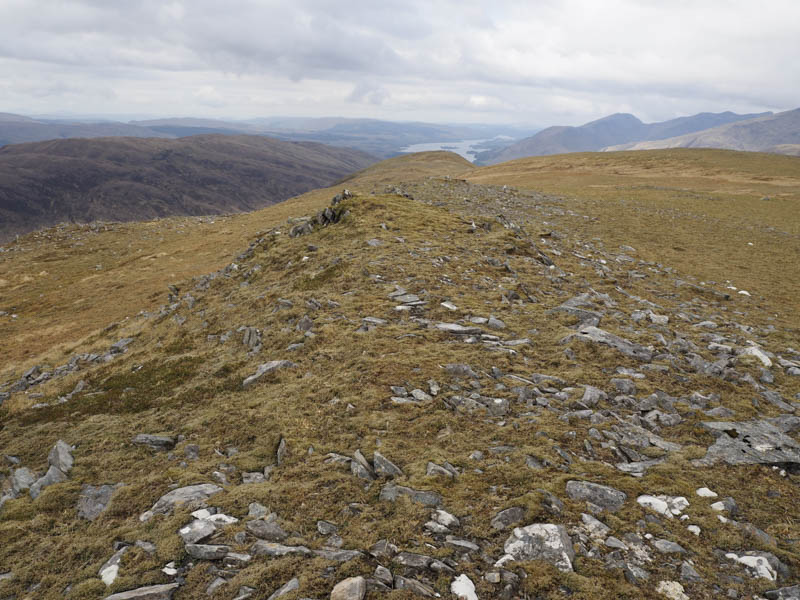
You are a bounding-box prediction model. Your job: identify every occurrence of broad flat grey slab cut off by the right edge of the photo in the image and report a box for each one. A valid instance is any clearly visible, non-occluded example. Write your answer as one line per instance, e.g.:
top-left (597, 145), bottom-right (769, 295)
top-left (692, 421), bottom-right (800, 467)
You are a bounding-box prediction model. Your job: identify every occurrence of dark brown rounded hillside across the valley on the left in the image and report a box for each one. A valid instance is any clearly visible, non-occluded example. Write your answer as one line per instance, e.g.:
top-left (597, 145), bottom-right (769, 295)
top-left (0, 135), bottom-right (374, 241)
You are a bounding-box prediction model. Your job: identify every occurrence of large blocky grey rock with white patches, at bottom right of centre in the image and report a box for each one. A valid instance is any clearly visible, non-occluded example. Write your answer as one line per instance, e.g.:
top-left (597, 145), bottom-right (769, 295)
top-left (496, 523), bottom-right (575, 571)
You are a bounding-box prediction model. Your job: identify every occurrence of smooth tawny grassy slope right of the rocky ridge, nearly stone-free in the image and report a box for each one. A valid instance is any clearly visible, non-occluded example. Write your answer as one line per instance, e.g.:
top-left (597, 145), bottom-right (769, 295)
top-left (465, 149), bottom-right (800, 318)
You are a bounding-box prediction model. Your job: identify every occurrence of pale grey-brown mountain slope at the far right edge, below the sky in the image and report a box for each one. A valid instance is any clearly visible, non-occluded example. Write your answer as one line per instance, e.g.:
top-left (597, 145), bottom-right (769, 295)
top-left (605, 108), bottom-right (800, 154)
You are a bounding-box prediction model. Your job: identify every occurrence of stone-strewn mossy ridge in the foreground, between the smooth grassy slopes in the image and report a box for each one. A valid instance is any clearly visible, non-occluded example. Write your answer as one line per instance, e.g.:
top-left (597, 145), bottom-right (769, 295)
top-left (0, 179), bottom-right (800, 600)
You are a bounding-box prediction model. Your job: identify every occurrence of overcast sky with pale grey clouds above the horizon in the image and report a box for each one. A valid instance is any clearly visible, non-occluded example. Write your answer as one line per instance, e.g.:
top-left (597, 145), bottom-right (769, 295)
top-left (0, 0), bottom-right (800, 125)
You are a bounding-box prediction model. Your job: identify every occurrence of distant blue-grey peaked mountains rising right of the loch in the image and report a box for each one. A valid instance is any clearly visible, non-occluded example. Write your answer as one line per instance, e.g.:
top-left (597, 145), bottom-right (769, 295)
top-left (478, 112), bottom-right (768, 165)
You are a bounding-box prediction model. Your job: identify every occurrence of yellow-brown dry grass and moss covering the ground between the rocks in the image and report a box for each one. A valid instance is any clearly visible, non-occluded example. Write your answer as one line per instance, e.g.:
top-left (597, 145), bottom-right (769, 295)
top-left (0, 146), bottom-right (800, 600)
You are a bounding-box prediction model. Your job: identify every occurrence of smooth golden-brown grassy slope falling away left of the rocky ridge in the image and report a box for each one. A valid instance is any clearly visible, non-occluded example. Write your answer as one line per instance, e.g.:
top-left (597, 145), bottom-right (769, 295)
top-left (0, 152), bottom-right (470, 378)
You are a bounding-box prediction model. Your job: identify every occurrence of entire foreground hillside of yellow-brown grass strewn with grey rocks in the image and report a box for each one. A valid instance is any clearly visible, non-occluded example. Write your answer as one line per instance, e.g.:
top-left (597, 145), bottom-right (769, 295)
top-left (0, 150), bottom-right (800, 600)
